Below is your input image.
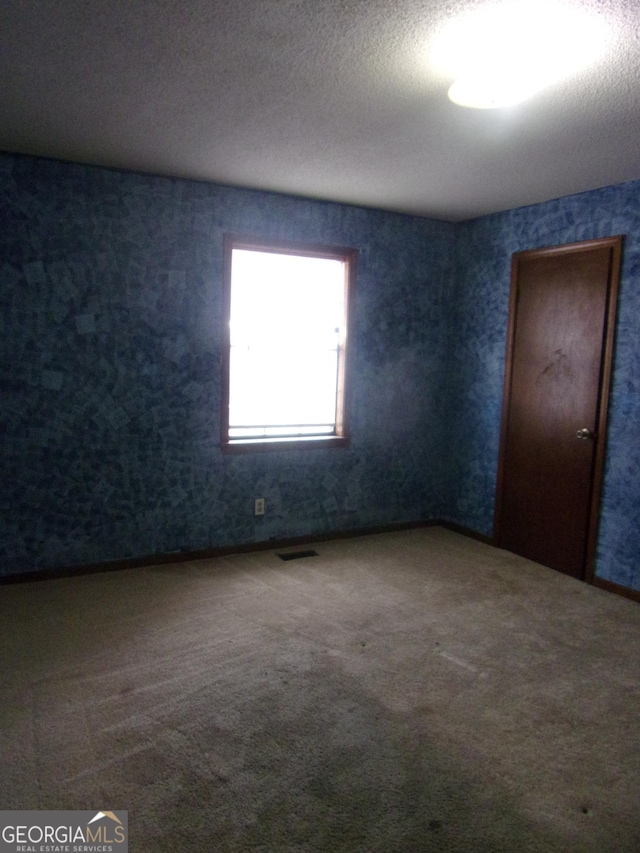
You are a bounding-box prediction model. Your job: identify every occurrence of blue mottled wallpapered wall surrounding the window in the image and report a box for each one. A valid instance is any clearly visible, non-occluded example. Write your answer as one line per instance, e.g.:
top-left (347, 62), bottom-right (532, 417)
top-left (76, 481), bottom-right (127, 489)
top-left (0, 155), bottom-right (454, 574)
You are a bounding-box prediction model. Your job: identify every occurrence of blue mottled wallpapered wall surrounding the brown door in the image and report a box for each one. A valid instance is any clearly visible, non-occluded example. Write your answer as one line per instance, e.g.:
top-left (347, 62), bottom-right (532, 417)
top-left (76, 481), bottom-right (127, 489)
top-left (443, 182), bottom-right (640, 589)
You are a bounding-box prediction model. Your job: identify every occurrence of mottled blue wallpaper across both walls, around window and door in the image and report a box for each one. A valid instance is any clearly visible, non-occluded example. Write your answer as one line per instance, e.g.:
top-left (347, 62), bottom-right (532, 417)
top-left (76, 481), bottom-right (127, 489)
top-left (0, 155), bottom-right (640, 589)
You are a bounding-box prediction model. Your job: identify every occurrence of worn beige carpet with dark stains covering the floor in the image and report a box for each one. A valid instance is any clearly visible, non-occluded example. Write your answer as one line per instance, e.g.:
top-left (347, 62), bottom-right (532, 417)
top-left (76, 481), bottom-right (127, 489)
top-left (0, 528), bottom-right (640, 853)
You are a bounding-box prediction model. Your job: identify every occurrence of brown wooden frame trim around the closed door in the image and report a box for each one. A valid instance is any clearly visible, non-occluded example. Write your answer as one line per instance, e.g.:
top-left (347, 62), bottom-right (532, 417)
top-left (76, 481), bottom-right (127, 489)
top-left (493, 236), bottom-right (622, 583)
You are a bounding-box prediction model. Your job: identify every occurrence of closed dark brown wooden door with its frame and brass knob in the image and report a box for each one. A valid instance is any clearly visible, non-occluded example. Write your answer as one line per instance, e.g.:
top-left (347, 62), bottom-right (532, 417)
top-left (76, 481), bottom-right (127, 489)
top-left (494, 237), bottom-right (622, 580)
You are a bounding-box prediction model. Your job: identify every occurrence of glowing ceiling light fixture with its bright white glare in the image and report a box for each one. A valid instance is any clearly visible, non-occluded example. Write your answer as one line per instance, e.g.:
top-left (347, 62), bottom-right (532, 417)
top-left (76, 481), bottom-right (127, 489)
top-left (431, 0), bottom-right (608, 109)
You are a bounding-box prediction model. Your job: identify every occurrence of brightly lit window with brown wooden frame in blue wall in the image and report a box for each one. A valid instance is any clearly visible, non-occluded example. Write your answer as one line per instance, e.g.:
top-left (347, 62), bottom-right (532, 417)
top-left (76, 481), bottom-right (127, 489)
top-left (222, 237), bottom-right (356, 450)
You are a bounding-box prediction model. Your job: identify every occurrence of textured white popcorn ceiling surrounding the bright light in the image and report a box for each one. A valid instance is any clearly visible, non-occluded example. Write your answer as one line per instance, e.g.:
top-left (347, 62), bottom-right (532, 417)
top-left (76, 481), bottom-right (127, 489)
top-left (0, 0), bottom-right (640, 221)
